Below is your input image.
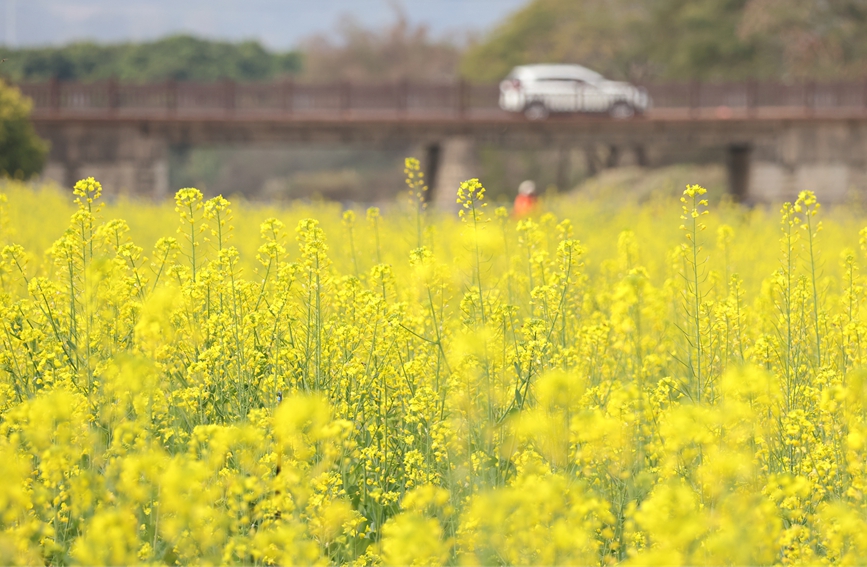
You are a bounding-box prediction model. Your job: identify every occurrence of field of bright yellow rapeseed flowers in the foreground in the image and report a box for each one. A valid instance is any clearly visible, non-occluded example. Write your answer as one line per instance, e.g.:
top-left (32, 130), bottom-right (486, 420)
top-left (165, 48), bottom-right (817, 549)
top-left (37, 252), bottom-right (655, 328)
top-left (0, 159), bottom-right (867, 565)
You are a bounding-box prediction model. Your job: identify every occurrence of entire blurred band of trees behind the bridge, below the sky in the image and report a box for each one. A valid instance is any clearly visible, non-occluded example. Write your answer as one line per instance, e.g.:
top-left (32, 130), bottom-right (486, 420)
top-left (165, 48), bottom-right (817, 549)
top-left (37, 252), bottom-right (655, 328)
top-left (0, 0), bottom-right (867, 82)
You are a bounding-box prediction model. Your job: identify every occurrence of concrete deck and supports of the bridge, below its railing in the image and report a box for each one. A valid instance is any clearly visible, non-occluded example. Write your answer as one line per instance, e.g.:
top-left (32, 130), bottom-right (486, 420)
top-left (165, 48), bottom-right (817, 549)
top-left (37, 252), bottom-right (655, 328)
top-left (35, 112), bottom-right (867, 210)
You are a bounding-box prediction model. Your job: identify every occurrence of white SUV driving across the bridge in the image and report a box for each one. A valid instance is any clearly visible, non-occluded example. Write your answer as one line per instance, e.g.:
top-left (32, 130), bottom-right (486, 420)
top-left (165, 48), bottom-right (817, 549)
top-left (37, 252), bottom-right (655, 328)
top-left (500, 65), bottom-right (650, 120)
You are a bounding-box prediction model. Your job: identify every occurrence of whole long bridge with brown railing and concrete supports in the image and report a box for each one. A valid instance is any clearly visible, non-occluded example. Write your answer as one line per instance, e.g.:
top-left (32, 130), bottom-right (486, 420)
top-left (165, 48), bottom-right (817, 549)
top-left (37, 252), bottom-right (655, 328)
top-left (18, 80), bottom-right (867, 202)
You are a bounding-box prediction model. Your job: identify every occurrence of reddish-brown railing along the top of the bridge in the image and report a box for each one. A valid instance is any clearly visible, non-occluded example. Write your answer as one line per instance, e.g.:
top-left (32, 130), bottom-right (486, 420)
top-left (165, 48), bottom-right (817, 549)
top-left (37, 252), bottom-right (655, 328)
top-left (18, 80), bottom-right (867, 120)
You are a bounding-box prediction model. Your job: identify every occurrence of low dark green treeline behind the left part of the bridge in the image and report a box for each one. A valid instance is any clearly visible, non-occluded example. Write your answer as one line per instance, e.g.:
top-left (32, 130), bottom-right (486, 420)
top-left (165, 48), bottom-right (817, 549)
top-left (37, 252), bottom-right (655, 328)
top-left (0, 35), bottom-right (301, 82)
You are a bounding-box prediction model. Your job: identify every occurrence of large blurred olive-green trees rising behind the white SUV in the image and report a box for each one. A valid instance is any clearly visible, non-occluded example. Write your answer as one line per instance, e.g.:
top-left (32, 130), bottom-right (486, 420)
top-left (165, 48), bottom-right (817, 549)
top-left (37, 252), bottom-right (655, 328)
top-left (461, 0), bottom-right (867, 81)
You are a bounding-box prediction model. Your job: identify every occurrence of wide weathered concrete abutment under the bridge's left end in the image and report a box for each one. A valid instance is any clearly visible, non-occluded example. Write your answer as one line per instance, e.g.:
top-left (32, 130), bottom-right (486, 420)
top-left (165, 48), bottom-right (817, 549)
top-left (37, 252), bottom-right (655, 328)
top-left (41, 123), bottom-right (169, 199)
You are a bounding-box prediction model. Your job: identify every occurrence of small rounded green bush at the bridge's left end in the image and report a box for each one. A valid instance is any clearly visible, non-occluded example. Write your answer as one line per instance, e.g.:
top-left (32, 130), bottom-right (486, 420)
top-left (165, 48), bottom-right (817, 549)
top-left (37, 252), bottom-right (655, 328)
top-left (0, 80), bottom-right (48, 177)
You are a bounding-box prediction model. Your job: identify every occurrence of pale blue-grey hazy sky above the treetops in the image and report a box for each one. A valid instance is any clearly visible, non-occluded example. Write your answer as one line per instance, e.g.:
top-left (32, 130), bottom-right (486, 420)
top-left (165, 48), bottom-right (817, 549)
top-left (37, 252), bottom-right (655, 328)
top-left (0, 0), bottom-right (527, 50)
